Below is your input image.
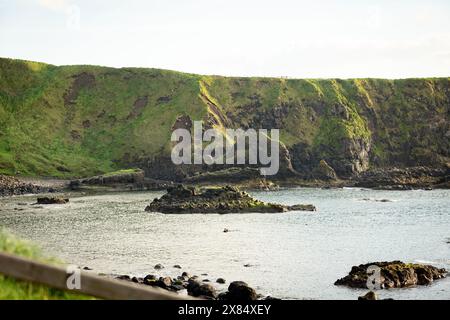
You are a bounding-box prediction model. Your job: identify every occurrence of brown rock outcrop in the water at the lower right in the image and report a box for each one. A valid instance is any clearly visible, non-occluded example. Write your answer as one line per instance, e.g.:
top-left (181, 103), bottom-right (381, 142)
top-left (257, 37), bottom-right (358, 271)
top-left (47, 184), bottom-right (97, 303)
top-left (334, 261), bottom-right (447, 289)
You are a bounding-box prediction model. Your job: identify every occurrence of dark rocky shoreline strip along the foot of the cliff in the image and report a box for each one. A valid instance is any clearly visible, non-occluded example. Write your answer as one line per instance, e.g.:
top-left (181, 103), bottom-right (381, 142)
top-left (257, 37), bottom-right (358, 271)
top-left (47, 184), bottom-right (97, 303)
top-left (0, 163), bottom-right (450, 197)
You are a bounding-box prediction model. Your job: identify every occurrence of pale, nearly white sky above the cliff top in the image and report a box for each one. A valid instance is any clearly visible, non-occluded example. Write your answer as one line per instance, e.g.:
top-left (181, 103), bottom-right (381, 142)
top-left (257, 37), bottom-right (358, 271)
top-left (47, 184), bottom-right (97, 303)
top-left (0, 0), bottom-right (450, 78)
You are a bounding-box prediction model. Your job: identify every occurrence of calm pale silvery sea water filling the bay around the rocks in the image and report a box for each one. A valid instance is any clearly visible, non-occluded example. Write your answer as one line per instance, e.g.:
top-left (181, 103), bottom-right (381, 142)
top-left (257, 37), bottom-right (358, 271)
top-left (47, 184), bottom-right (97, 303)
top-left (0, 188), bottom-right (450, 299)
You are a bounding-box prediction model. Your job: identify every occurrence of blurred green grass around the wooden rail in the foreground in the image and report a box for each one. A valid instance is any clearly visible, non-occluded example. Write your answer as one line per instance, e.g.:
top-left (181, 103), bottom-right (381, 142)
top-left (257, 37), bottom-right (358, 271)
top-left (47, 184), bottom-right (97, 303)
top-left (0, 229), bottom-right (93, 300)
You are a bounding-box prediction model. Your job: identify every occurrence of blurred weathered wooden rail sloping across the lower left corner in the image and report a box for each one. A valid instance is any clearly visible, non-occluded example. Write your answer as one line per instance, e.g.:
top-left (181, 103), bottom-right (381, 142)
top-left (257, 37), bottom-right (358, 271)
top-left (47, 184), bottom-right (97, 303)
top-left (0, 252), bottom-right (194, 300)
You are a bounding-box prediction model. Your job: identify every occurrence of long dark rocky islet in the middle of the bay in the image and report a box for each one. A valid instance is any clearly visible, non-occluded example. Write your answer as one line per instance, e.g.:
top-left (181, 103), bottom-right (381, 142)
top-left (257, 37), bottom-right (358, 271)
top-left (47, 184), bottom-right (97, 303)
top-left (145, 185), bottom-right (315, 213)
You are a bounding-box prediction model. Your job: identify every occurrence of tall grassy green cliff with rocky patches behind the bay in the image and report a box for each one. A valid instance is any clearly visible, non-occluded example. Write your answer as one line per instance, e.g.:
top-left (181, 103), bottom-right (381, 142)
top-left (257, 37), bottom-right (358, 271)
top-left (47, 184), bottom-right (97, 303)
top-left (0, 59), bottom-right (450, 179)
